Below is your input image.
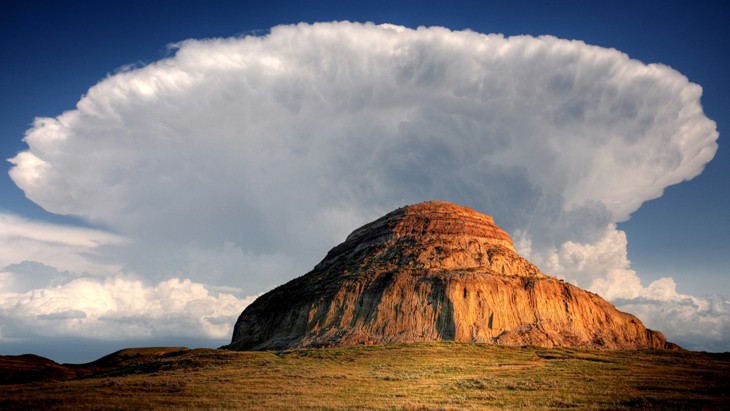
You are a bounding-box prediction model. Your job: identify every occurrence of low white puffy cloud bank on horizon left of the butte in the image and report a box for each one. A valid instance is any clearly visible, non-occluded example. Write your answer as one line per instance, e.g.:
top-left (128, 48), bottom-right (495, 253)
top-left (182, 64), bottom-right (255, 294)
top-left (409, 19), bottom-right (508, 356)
top-left (0, 276), bottom-right (255, 339)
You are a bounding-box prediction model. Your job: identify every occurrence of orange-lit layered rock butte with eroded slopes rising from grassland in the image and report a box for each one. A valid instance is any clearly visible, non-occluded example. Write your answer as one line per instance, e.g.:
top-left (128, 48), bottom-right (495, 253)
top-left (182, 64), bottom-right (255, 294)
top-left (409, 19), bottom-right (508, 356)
top-left (224, 202), bottom-right (676, 350)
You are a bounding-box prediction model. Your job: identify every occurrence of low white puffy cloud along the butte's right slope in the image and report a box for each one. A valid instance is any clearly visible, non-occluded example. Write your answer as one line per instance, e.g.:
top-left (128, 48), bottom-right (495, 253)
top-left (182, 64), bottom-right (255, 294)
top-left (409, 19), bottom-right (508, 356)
top-left (523, 224), bottom-right (730, 351)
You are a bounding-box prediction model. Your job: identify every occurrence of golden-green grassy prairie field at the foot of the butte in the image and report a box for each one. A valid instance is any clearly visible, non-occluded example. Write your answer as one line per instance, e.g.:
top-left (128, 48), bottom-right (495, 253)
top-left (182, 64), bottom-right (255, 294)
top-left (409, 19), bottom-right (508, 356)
top-left (0, 342), bottom-right (730, 410)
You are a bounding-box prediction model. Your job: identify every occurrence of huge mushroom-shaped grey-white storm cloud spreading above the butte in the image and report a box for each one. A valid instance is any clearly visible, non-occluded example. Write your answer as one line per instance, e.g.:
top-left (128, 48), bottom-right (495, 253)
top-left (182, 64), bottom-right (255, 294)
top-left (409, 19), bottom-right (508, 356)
top-left (10, 22), bottom-right (718, 250)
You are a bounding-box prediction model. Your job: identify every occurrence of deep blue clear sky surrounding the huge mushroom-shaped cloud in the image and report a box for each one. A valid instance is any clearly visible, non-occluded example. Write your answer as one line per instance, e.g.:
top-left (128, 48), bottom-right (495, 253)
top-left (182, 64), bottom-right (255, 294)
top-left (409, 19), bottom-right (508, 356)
top-left (0, 0), bottom-right (730, 296)
